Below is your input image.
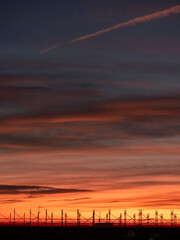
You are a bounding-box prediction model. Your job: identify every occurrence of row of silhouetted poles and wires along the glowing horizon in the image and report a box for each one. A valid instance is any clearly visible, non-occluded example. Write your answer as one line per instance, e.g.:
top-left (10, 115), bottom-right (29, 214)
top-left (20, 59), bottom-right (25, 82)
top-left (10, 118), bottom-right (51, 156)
top-left (0, 209), bottom-right (180, 227)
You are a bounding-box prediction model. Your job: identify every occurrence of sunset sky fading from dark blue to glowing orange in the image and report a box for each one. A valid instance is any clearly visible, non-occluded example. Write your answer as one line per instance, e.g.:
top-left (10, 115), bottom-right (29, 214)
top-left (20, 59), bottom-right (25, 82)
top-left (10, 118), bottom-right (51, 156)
top-left (0, 0), bottom-right (180, 218)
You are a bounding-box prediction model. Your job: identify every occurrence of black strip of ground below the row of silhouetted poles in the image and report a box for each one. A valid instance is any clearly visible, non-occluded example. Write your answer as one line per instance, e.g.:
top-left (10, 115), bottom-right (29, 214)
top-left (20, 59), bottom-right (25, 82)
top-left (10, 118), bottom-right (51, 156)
top-left (0, 227), bottom-right (180, 240)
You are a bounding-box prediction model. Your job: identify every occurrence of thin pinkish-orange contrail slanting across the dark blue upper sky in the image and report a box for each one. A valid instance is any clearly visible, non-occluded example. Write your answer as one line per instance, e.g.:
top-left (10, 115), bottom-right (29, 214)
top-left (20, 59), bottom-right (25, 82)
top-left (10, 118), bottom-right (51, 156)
top-left (39, 5), bottom-right (180, 54)
